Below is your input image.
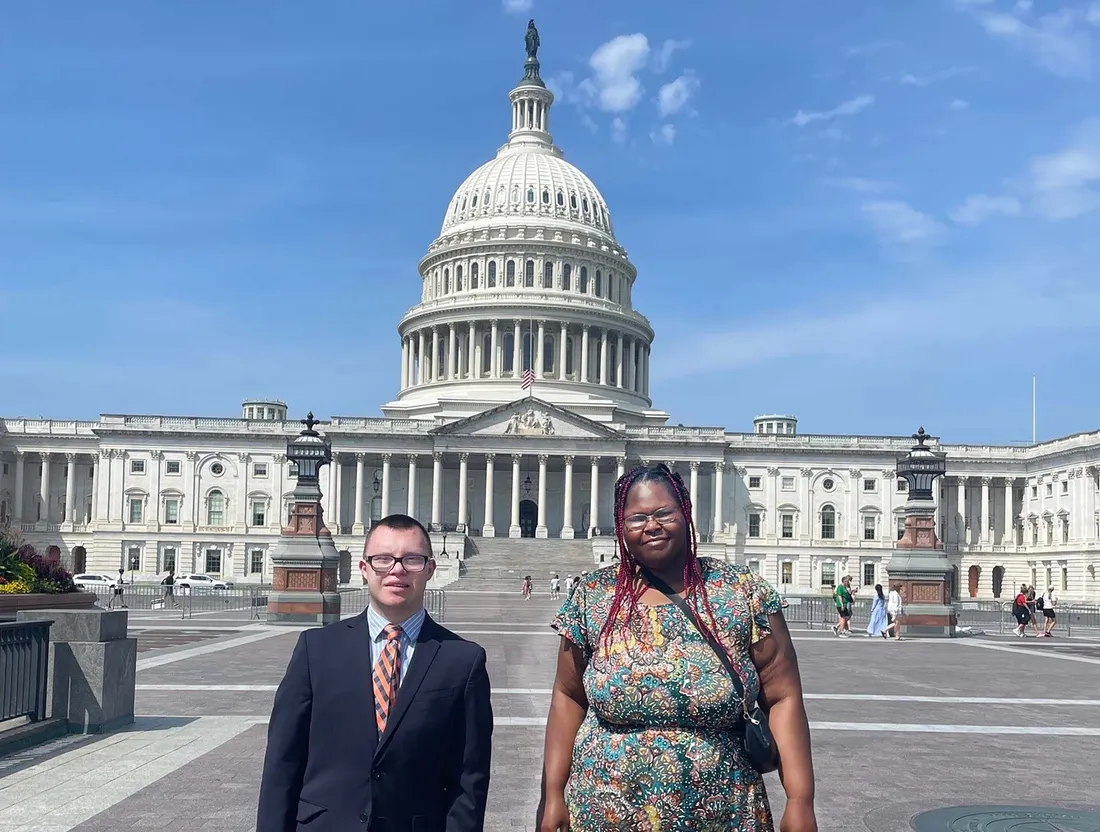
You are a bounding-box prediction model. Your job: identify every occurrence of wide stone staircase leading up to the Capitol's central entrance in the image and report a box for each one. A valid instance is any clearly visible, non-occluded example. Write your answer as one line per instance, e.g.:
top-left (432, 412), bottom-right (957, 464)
top-left (447, 537), bottom-right (602, 594)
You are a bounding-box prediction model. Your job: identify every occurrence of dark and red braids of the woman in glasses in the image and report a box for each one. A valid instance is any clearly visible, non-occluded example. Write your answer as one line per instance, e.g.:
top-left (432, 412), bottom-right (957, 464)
top-left (600, 463), bottom-right (721, 645)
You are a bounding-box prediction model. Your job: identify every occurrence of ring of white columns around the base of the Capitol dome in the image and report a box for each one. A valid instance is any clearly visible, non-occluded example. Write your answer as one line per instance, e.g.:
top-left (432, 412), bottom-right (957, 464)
top-left (400, 319), bottom-right (649, 396)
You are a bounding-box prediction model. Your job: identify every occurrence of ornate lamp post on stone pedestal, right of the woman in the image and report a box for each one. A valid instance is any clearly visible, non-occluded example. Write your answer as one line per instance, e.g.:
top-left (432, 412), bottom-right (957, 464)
top-left (887, 427), bottom-right (957, 637)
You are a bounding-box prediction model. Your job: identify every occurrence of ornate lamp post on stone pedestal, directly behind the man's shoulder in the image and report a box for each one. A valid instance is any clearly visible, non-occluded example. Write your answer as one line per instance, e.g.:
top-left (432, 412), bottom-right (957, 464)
top-left (267, 413), bottom-right (340, 624)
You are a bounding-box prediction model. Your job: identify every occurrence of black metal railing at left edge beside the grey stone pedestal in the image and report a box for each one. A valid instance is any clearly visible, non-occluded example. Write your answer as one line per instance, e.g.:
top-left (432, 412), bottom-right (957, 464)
top-left (0, 621), bottom-right (53, 722)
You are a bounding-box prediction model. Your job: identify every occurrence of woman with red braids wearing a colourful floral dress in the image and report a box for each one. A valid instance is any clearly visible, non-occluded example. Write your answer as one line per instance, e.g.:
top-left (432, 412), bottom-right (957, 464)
top-left (537, 466), bottom-right (817, 832)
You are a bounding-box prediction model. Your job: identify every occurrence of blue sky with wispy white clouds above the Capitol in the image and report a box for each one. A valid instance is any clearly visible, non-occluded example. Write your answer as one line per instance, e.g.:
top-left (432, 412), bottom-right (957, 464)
top-left (0, 0), bottom-right (1100, 442)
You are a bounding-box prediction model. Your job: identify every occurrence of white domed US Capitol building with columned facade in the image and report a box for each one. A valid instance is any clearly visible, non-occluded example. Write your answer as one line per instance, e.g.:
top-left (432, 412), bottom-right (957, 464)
top-left (0, 30), bottom-right (1100, 600)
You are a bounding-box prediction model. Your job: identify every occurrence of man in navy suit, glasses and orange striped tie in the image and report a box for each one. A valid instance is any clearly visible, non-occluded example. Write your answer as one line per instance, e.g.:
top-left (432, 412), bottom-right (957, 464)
top-left (256, 514), bottom-right (493, 832)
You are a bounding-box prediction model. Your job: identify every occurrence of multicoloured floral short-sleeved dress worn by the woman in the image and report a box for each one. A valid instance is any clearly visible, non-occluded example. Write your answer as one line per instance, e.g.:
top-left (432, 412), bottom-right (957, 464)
top-left (551, 558), bottom-right (781, 832)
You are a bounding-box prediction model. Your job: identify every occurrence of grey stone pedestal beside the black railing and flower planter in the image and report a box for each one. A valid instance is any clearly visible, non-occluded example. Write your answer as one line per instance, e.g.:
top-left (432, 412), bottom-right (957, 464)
top-left (17, 609), bottom-right (138, 734)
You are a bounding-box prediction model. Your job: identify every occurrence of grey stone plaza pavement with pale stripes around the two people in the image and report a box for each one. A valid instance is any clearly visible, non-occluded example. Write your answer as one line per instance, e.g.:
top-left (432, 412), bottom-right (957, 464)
top-left (0, 592), bottom-right (1100, 832)
